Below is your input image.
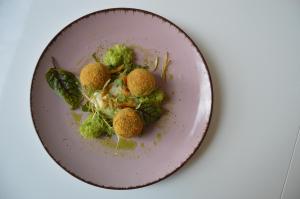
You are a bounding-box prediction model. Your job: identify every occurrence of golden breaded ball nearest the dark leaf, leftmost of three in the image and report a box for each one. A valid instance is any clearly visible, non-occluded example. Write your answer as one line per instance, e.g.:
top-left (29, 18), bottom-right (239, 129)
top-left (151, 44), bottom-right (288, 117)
top-left (80, 63), bottom-right (110, 90)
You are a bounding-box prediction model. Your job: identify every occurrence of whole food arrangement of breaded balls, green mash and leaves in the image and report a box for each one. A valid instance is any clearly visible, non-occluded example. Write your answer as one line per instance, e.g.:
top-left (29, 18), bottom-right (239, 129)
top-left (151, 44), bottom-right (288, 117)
top-left (46, 44), bottom-right (169, 145)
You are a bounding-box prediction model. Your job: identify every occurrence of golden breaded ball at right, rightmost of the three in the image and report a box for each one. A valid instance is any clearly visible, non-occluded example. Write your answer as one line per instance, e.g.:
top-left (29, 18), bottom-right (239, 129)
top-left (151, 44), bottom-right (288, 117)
top-left (127, 68), bottom-right (156, 97)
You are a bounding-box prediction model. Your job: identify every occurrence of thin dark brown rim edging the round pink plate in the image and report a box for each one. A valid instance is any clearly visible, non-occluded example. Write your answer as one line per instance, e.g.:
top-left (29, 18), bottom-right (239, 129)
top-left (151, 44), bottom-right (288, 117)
top-left (30, 7), bottom-right (214, 190)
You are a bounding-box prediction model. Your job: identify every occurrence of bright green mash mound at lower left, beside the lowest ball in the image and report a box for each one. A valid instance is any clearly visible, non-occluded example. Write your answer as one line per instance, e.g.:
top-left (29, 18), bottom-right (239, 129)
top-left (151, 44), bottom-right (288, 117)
top-left (79, 112), bottom-right (114, 138)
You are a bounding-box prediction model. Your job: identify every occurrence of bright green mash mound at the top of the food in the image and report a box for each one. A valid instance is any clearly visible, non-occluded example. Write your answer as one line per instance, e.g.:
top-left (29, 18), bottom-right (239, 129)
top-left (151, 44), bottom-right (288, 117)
top-left (103, 44), bottom-right (134, 68)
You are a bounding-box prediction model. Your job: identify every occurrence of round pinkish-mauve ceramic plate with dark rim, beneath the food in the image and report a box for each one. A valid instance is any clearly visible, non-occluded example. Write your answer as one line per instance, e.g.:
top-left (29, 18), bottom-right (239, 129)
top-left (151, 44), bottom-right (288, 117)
top-left (30, 8), bottom-right (212, 189)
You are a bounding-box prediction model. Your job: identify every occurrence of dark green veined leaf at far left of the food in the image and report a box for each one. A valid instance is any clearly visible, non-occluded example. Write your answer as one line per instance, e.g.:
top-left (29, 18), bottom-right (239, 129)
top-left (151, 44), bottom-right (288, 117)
top-left (45, 67), bottom-right (82, 109)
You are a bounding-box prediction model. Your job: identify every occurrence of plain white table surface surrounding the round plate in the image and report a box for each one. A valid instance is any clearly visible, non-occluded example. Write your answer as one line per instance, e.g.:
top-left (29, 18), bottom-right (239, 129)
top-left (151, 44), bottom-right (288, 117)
top-left (0, 0), bottom-right (300, 199)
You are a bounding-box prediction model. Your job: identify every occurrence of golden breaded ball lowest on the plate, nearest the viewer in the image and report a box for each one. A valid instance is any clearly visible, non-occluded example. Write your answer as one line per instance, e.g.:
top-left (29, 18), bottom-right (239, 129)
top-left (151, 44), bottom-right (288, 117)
top-left (113, 108), bottom-right (144, 138)
